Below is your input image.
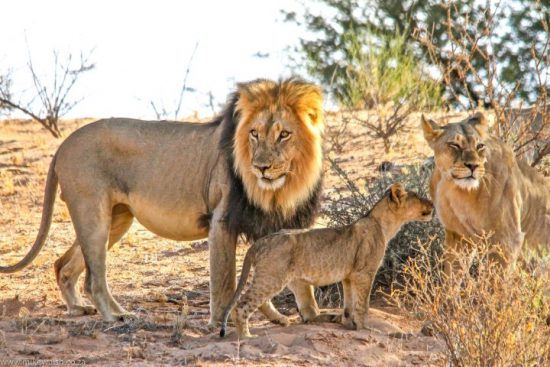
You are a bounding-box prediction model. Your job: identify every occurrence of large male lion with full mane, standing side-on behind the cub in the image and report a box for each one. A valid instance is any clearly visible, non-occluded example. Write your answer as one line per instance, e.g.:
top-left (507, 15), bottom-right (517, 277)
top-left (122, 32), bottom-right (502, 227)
top-left (0, 78), bottom-right (323, 324)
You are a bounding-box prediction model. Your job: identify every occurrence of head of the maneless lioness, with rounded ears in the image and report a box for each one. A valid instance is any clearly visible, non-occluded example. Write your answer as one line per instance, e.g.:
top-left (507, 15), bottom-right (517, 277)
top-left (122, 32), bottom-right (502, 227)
top-left (422, 112), bottom-right (488, 190)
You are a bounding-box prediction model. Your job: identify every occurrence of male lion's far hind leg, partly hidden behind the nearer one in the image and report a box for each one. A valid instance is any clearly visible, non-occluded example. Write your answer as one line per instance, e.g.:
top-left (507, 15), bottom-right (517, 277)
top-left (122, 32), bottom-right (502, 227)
top-left (54, 206), bottom-right (133, 316)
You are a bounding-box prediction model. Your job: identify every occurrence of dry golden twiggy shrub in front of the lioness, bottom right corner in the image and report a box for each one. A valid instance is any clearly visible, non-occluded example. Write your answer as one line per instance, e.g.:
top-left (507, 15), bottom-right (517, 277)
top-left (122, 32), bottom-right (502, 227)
top-left (390, 238), bottom-right (550, 367)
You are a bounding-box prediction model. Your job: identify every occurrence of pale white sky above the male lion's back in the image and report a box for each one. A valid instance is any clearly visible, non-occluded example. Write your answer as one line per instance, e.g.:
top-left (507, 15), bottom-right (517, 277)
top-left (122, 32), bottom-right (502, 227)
top-left (0, 0), bottom-right (303, 118)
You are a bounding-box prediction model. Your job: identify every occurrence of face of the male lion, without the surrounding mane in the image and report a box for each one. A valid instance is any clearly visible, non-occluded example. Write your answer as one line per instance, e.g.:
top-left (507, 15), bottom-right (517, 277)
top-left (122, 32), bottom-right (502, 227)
top-left (248, 111), bottom-right (299, 190)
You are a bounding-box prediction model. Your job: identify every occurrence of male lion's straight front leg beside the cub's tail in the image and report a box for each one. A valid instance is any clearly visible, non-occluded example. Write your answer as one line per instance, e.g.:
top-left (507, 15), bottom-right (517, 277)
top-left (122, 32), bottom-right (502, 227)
top-left (208, 207), bottom-right (237, 327)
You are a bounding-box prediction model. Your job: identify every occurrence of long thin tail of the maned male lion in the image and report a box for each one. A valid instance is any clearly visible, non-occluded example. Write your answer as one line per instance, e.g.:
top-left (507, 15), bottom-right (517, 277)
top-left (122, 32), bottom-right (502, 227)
top-left (0, 153), bottom-right (58, 273)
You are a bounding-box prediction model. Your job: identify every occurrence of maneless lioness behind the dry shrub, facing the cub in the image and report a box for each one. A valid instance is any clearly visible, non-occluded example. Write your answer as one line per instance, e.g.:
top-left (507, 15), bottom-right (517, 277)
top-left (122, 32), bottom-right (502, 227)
top-left (422, 112), bottom-right (550, 274)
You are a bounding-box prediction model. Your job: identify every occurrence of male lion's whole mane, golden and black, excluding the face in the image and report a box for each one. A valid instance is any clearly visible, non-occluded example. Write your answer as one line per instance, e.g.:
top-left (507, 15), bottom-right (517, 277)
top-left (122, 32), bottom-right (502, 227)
top-left (218, 78), bottom-right (324, 240)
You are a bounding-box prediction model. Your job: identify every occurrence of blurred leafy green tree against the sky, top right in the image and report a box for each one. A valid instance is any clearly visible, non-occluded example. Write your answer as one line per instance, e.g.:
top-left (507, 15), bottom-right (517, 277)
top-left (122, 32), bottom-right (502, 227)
top-left (283, 0), bottom-right (550, 107)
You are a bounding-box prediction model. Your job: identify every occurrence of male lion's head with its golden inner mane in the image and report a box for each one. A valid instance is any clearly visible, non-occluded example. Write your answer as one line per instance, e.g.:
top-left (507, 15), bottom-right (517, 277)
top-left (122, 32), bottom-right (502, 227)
top-left (233, 79), bottom-right (323, 215)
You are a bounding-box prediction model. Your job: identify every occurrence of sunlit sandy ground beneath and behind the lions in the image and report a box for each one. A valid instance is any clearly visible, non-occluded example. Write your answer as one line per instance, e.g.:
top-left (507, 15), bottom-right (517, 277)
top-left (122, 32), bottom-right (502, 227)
top-left (0, 116), bottom-right (452, 366)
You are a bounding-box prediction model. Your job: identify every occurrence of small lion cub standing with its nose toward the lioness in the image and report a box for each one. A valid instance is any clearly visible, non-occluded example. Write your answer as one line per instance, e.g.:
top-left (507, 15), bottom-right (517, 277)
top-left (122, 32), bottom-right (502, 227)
top-left (220, 183), bottom-right (433, 338)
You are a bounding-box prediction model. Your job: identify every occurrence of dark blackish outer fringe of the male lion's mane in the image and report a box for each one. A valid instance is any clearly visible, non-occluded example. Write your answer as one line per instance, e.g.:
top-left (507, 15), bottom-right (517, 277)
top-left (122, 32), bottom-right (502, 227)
top-left (216, 93), bottom-right (322, 240)
